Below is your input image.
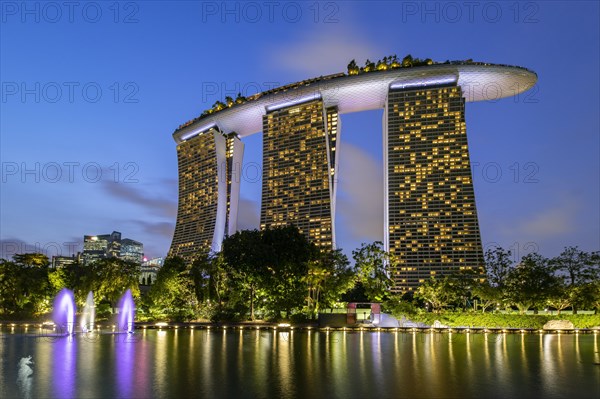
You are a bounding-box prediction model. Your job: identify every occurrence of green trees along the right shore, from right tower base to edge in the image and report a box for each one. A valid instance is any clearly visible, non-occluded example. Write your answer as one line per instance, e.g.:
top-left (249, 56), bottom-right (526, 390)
top-left (415, 247), bottom-right (600, 314)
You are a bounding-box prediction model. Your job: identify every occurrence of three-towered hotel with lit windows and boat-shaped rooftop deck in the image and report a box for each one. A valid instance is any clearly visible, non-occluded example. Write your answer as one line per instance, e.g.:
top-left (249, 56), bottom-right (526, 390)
top-left (170, 63), bottom-right (537, 292)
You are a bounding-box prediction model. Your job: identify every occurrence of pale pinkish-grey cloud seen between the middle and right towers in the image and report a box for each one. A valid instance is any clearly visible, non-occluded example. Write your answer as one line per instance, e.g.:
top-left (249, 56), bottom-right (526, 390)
top-left (336, 143), bottom-right (383, 241)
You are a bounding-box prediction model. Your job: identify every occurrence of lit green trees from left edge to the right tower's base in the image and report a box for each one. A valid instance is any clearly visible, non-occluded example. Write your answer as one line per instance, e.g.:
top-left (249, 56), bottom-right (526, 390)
top-left (0, 226), bottom-right (391, 321)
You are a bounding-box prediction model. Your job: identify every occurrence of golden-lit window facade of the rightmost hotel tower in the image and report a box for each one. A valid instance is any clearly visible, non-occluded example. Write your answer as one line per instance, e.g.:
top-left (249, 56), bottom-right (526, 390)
top-left (387, 86), bottom-right (483, 292)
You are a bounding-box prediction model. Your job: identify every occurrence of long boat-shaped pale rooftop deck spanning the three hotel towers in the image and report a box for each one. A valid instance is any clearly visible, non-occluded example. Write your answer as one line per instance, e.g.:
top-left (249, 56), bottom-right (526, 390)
top-left (173, 64), bottom-right (537, 143)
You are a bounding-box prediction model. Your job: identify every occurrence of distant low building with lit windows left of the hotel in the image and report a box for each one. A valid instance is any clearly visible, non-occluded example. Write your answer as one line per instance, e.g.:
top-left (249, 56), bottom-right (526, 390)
top-left (82, 231), bottom-right (144, 266)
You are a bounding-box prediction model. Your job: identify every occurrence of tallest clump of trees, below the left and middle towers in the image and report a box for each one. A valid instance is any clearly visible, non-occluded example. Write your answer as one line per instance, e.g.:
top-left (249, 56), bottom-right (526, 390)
top-left (144, 226), bottom-right (392, 321)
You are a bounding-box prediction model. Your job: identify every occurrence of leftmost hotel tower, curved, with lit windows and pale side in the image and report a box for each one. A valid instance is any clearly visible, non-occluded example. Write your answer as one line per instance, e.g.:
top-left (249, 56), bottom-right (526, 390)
top-left (169, 126), bottom-right (244, 262)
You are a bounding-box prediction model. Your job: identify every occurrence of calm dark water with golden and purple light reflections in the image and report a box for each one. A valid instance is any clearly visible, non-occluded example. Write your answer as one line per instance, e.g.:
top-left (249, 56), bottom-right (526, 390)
top-left (0, 329), bottom-right (600, 399)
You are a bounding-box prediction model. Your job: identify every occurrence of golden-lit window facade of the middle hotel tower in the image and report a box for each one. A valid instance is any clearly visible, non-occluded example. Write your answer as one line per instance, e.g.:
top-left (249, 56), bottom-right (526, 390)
top-left (261, 100), bottom-right (338, 248)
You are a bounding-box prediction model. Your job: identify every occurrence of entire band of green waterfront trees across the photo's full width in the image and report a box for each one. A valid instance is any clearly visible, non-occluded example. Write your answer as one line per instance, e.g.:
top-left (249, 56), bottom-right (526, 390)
top-left (0, 226), bottom-right (600, 321)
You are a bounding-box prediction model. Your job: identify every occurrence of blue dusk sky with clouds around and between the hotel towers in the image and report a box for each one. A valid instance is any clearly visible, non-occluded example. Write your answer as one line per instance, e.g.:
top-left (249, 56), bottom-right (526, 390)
top-left (0, 1), bottom-right (600, 257)
